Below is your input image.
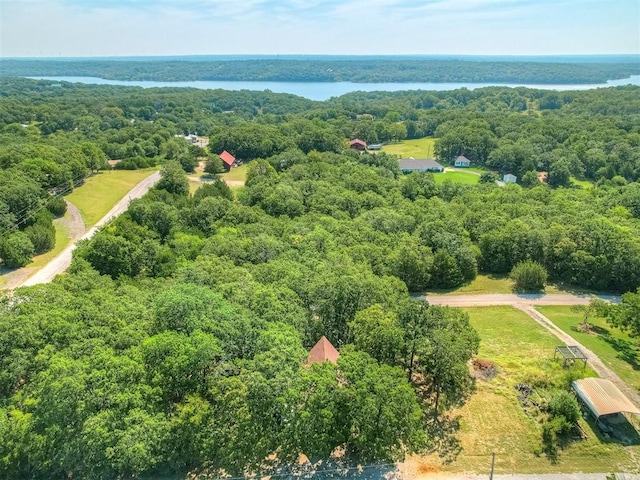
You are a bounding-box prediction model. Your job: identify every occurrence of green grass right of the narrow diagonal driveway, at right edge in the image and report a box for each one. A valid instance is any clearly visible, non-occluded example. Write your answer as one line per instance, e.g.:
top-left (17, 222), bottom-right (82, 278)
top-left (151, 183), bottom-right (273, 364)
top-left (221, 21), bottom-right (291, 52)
top-left (536, 306), bottom-right (640, 389)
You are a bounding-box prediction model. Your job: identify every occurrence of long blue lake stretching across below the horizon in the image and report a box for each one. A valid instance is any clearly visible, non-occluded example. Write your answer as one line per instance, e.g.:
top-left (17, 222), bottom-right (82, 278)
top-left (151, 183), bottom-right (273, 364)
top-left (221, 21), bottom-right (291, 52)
top-left (29, 75), bottom-right (640, 101)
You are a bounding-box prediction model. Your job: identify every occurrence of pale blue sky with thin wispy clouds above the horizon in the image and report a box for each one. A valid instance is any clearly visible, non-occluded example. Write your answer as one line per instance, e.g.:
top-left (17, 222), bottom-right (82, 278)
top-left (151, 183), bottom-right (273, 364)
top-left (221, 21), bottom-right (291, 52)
top-left (0, 0), bottom-right (640, 57)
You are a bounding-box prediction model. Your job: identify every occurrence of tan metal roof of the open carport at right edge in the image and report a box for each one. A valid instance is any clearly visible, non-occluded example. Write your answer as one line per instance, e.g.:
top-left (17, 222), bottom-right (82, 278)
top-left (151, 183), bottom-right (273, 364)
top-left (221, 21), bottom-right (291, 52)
top-left (571, 378), bottom-right (640, 418)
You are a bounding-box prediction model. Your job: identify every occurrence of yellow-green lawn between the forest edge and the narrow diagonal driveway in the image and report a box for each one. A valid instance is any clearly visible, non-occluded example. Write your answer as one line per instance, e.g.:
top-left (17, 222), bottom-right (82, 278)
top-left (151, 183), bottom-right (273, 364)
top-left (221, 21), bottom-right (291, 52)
top-left (422, 307), bottom-right (640, 474)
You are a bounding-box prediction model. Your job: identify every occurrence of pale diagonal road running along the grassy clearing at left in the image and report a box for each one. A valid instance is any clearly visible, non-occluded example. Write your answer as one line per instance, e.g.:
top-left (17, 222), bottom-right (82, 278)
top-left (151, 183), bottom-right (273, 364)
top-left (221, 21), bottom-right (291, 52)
top-left (20, 172), bottom-right (160, 287)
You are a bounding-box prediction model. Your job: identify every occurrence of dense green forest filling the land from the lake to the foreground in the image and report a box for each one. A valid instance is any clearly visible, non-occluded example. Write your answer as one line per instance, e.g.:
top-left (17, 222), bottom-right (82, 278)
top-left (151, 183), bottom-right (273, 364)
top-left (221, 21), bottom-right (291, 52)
top-left (0, 79), bottom-right (640, 479)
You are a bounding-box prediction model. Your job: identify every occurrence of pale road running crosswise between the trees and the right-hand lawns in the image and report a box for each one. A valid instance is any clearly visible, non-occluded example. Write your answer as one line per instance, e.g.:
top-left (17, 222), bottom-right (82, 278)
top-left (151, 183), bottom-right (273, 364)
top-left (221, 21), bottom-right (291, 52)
top-left (417, 293), bottom-right (620, 307)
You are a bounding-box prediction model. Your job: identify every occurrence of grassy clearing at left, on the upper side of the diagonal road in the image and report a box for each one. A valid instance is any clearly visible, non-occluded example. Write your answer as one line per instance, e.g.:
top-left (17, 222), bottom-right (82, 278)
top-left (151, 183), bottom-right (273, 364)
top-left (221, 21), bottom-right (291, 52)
top-left (66, 168), bottom-right (157, 228)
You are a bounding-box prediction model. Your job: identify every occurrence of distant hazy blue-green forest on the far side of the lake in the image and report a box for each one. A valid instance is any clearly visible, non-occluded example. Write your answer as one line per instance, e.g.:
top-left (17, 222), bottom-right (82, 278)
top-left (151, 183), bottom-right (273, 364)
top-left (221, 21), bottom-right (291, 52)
top-left (0, 57), bottom-right (640, 84)
